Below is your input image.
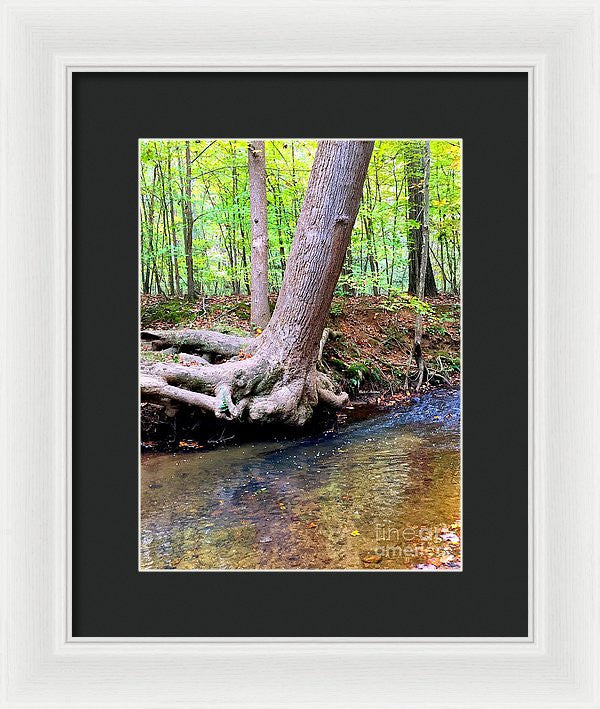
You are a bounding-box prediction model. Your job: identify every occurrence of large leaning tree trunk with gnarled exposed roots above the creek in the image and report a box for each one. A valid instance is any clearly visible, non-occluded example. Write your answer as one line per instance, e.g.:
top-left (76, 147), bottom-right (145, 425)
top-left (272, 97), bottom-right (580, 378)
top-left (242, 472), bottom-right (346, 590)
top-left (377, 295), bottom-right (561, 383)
top-left (141, 140), bottom-right (373, 426)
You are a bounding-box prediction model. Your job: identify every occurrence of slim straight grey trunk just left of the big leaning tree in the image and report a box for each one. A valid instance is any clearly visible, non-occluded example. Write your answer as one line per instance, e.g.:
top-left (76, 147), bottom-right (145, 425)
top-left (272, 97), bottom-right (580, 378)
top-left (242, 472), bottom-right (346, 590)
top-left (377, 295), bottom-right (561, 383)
top-left (248, 140), bottom-right (271, 328)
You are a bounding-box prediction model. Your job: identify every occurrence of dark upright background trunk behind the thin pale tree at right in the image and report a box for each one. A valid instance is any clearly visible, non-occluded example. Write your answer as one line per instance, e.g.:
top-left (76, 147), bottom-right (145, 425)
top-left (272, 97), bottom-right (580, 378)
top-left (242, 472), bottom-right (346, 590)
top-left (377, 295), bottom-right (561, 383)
top-left (405, 142), bottom-right (437, 296)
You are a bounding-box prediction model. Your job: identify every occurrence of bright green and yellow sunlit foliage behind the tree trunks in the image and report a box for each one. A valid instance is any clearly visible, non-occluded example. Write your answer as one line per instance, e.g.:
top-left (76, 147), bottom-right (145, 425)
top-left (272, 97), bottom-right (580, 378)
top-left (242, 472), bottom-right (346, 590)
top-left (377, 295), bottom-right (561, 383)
top-left (139, 139), bottom-right (461, 295)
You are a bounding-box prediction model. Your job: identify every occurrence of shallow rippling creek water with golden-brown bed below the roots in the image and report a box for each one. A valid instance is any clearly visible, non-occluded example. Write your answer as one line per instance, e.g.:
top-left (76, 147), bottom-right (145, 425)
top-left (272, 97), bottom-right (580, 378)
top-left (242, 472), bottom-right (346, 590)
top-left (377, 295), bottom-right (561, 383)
top-left (140, 390), bottom-right (460, 570)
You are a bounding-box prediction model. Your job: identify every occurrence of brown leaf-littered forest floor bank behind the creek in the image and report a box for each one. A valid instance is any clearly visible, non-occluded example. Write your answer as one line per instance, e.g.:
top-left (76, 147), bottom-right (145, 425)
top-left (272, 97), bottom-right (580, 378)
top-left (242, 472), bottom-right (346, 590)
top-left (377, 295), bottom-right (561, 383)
top-left (141, 294), bottom-right (461, 448)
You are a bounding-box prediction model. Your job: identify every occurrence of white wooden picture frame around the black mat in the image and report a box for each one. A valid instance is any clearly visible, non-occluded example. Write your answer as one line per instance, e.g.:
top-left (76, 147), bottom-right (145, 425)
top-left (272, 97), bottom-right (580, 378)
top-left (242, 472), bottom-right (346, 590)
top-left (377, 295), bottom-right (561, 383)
top-left (0, 0), bottom-right (600, 709)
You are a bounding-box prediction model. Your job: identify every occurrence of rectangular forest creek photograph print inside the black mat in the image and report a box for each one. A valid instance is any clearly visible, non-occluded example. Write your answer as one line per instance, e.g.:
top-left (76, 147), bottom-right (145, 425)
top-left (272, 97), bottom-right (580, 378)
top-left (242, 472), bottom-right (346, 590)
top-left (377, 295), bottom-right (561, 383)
top-left (138, 137), bottom-right (463, 572)
